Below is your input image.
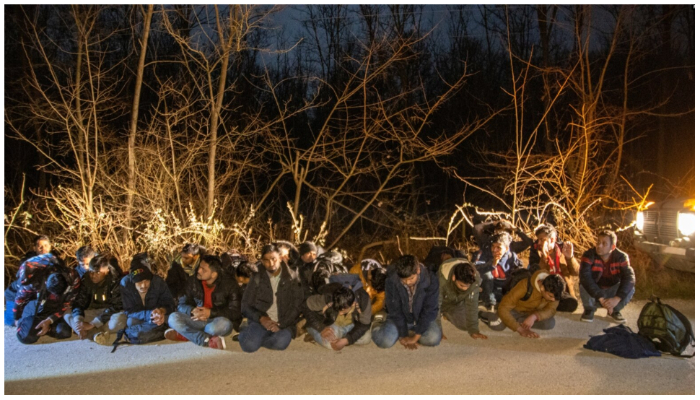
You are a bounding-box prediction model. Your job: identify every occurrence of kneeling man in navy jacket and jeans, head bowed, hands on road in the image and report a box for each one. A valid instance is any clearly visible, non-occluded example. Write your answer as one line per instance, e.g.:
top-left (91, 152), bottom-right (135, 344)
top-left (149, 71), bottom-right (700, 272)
top-left (372, 255), bottom-right (442, 350)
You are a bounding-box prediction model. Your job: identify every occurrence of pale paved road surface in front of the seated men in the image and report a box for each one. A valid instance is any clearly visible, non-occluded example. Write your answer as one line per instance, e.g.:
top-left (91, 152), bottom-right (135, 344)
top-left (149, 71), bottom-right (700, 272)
top-left (4, 301), bottom-right (695, 395)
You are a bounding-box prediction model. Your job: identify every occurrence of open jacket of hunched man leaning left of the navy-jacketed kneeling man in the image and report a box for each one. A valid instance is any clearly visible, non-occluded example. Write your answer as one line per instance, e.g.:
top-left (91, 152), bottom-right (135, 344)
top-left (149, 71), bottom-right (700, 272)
top-left (302, 282), bottom-right (372, 344)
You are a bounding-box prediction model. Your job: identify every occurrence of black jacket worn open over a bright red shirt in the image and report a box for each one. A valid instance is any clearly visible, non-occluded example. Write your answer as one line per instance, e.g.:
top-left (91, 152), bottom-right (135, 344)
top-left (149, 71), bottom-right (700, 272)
top-left (177, 274), bottom-right (243, 331)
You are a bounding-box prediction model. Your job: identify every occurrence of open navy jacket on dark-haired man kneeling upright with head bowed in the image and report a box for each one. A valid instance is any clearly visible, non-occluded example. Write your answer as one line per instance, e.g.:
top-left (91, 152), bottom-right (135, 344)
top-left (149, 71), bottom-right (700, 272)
top-left (386, 265), bottom-right (440, 337)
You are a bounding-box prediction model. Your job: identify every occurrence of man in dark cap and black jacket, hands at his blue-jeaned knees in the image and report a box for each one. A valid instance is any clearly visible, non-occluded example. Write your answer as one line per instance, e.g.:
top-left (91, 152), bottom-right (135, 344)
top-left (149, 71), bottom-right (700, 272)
top-left (120, 253), bottom-right (175, 343)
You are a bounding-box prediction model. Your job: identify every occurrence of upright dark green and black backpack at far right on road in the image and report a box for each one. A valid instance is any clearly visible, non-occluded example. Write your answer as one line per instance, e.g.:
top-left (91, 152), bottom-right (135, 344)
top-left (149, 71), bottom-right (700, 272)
top-left (637, 296), bottom-right (695, 358)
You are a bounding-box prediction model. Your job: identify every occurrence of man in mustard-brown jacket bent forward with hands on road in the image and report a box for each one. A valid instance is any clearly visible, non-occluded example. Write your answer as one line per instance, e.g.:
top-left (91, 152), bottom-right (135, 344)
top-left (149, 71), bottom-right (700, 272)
top-left (498, 271), bottom-right (564, 338)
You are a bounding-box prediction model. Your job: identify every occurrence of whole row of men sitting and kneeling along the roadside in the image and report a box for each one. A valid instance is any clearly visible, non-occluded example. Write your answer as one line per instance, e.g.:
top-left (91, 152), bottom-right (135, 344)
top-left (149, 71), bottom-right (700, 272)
top-left (5, 222), bottom-right (635, 352)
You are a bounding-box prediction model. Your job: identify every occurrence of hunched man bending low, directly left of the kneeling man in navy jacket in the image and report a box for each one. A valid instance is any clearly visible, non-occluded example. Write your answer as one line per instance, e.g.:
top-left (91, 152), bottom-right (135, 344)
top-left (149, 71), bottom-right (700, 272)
top-left (303, 280), bottom-right (372, 350)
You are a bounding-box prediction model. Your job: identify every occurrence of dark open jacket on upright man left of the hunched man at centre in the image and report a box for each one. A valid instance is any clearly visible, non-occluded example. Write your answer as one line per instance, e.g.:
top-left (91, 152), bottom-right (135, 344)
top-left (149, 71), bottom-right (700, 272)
top-left (241, 262), bottom-right (304, 337)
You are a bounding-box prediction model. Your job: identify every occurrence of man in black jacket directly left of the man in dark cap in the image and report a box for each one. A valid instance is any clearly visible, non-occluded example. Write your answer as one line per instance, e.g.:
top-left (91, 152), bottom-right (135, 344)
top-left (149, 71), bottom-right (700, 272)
top-left (63, 255), bottom-right (126, 345)
